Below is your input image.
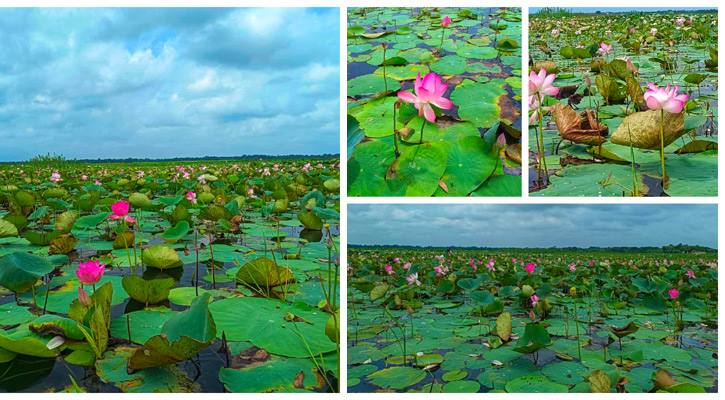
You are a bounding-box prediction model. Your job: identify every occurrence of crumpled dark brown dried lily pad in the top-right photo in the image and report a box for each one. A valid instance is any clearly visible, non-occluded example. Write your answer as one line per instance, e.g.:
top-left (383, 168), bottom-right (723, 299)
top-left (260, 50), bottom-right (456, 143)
top-left (551, 103), bottom-right (609, 146)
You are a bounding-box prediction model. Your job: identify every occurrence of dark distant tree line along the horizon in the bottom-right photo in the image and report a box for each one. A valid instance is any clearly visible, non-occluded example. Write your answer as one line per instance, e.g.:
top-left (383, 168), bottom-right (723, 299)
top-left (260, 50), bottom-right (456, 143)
top-left (347, 243), bottom-right (717, 254)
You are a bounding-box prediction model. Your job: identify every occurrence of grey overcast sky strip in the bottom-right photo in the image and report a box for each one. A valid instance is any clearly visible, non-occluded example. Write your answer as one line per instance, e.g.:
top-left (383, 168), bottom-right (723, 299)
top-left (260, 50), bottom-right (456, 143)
top-left (347, 204), bottom-right (717, 248)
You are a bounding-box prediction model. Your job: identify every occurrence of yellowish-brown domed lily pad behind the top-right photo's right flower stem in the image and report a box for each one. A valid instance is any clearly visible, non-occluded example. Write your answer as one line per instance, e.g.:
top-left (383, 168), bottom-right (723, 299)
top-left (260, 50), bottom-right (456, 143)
top-left (612, 110), bottom-right (685, 150)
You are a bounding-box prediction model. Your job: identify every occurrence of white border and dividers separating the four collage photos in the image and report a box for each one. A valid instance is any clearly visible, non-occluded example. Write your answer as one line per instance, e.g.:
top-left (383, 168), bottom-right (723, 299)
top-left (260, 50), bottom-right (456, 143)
top-left (0, 0), bottom-right (725, 400)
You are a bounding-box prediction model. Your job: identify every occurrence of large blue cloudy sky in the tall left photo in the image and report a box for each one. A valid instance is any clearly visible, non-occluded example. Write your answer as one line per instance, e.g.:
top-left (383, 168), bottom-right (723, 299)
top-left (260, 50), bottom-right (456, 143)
top-left (0, 8), bottom-right (340, 161)
